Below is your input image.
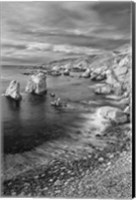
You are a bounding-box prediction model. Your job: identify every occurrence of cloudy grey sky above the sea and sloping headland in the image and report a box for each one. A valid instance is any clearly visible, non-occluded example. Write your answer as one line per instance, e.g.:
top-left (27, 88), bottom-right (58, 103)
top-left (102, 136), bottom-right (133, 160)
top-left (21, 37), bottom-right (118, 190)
top-left (1, 1), bottom-right (131, 65)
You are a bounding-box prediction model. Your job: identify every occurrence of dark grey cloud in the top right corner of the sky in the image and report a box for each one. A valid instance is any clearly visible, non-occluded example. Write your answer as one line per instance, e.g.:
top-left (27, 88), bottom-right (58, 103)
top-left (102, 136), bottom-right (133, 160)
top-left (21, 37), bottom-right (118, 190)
top-left (90, 2), bottom-right (132, 34)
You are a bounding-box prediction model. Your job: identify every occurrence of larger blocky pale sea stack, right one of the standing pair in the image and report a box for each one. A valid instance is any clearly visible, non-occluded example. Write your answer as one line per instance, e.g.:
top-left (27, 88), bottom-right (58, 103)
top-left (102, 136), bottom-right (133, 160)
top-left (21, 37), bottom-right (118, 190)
top-left (26, 72), bottom-right (47, 95)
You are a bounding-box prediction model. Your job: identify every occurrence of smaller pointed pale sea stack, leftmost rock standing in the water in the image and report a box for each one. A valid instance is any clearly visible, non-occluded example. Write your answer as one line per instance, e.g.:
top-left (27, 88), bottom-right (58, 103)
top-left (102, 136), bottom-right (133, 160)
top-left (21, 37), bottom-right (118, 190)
top-left (5, 80), bottom-right (22, 101)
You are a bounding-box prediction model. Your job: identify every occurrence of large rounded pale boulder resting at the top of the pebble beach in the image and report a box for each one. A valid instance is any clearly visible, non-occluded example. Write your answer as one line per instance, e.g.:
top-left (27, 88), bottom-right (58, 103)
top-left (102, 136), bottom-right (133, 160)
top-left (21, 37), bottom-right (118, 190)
top-left (97, 106), bottom-right (128, 124)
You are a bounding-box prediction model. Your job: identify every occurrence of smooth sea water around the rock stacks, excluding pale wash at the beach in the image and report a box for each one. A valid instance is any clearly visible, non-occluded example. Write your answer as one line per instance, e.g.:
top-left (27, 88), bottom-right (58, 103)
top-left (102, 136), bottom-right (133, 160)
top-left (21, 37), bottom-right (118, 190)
top-left (1, 67), bottom-right (101, 153)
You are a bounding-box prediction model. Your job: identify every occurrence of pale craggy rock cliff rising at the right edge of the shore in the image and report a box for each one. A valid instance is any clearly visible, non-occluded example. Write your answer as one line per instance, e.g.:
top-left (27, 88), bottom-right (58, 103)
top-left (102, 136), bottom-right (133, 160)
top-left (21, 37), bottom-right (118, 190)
top-left (91, 51), bottom-right (132, 99)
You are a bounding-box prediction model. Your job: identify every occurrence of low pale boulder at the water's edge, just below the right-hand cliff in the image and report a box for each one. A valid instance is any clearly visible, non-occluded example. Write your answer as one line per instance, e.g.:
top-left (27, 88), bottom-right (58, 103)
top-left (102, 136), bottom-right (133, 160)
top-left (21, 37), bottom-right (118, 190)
top-left (94, 85), bottom-right (113, 95)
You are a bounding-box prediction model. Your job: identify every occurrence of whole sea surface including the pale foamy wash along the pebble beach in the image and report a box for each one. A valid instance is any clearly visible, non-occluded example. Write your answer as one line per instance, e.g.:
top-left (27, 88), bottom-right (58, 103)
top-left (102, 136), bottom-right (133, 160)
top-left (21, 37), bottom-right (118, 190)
top-left (1, 67), bottom-right (110, 178)
